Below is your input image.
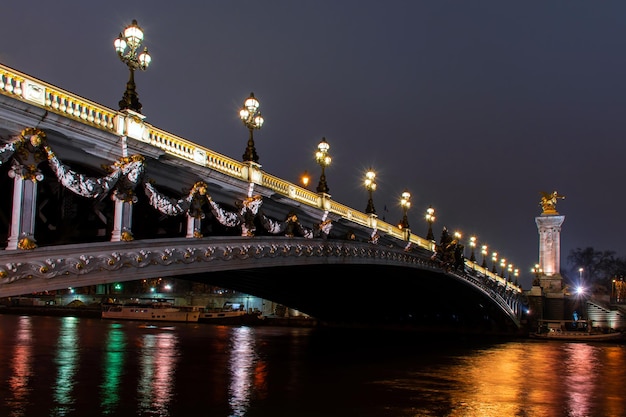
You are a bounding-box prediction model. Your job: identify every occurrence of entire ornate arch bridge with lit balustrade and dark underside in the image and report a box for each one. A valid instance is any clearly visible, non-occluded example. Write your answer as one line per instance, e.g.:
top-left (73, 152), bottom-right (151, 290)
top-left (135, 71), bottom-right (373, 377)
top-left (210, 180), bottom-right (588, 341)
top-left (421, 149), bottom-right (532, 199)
top-left (0, 66), bottom-right (523, 330)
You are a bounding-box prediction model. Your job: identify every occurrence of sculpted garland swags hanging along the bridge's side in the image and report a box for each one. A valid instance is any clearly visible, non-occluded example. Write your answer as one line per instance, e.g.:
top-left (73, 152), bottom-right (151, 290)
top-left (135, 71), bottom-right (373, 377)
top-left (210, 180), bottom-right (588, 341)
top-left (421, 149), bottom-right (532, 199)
top-left (0, 128), bottom-right (332, 245)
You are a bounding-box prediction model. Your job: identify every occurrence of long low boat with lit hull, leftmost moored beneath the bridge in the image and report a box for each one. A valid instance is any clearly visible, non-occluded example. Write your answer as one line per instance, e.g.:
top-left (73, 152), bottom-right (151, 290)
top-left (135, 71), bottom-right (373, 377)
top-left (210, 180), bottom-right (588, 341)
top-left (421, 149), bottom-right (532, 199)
top-left (102, 298), bottom-right (200, 323)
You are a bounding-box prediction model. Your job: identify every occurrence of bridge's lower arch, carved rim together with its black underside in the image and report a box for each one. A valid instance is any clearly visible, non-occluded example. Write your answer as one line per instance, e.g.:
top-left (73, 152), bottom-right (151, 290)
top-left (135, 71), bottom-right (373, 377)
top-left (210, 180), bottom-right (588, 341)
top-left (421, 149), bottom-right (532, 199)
top-left (0, 236), bottom-right (522, 331)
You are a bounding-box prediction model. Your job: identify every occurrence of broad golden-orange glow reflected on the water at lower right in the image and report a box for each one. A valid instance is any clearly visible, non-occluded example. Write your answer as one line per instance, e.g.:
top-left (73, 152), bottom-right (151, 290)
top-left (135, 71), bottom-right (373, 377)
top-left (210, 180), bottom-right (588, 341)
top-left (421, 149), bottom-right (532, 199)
top-left (386, 342), bottom-right (626, 417)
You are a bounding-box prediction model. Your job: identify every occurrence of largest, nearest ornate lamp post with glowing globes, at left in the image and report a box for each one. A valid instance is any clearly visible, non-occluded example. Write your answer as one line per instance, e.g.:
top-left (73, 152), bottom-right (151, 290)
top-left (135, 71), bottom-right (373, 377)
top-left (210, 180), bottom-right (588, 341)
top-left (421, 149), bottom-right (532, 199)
top-left (113, 19), bottom-right (152, 113)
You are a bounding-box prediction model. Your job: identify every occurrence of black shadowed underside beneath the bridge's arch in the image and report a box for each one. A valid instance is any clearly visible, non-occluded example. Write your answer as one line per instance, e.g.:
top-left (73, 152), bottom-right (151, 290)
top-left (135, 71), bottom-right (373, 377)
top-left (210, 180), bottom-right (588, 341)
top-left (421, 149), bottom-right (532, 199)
top-left (174, 264), bottom-right (519, 334)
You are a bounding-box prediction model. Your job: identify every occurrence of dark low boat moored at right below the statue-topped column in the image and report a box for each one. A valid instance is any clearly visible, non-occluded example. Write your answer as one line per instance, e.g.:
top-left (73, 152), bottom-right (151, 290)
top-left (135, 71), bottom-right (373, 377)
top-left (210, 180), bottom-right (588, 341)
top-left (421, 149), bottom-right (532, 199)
top-left (530, 320), bottom-right (626, 342)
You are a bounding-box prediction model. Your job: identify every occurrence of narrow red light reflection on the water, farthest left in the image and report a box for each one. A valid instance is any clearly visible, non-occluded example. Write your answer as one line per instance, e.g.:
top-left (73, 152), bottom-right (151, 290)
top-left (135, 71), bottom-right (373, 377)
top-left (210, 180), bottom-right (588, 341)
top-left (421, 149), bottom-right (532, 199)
top-left (7, 317), bottom-right (33, 417)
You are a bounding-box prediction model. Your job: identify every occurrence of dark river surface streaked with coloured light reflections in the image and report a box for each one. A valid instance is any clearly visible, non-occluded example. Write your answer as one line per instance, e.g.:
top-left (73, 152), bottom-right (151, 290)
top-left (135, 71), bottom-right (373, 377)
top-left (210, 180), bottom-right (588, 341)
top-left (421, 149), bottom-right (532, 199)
top-left (0, 315), bottom-right (626, 417)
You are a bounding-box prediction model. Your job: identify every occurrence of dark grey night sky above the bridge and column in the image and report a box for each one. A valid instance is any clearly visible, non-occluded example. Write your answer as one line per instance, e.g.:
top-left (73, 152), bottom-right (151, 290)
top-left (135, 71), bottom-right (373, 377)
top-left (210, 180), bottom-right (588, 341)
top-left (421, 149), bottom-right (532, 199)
top-left (0, 0), bottom-right (626, 288)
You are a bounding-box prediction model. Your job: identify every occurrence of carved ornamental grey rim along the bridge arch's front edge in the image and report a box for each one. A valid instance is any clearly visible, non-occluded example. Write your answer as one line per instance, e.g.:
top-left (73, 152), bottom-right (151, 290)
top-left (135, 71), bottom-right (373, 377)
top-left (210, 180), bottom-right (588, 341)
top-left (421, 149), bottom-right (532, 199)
top-left (0, 237), bottom-right (426, 286)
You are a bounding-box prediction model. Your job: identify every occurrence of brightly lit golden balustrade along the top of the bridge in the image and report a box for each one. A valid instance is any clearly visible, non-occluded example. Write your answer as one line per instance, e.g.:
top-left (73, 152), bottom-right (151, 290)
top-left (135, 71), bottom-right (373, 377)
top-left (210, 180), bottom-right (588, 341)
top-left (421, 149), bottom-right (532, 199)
top-left (0, 64), bottom-right (516, 292)
